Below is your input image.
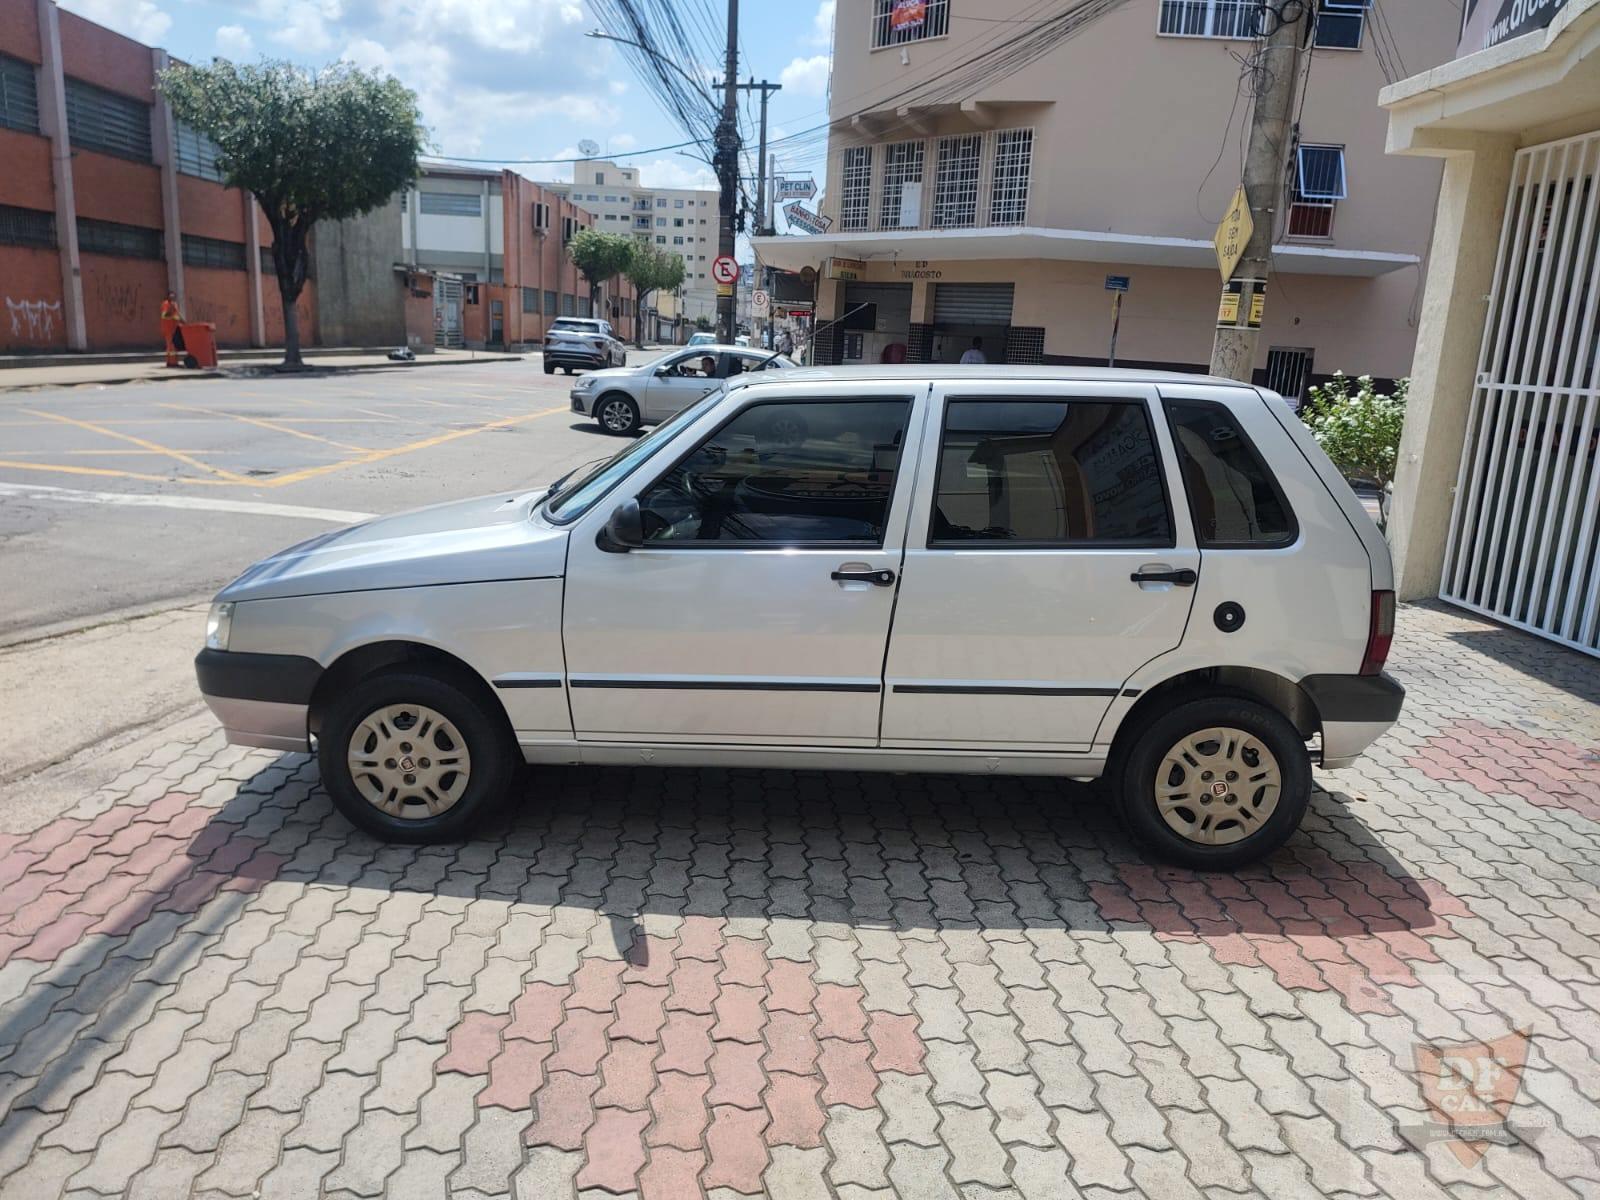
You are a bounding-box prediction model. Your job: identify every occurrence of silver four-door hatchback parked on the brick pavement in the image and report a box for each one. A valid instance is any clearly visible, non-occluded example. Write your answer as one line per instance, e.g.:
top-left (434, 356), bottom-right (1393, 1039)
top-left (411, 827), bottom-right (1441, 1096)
top-left (197, 366), bottom-right (1403, 869)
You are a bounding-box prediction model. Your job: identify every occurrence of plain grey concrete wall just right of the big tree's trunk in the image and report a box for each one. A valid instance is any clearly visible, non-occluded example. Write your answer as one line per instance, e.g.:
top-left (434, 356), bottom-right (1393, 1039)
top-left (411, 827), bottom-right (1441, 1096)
top-left (315, 195), bottom-right (406, 347)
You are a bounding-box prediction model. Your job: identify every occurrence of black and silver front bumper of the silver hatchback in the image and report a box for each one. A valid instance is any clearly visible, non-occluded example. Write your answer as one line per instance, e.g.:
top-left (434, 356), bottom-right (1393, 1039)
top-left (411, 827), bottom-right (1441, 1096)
top-left (195, 650), bottom-right (322, 752)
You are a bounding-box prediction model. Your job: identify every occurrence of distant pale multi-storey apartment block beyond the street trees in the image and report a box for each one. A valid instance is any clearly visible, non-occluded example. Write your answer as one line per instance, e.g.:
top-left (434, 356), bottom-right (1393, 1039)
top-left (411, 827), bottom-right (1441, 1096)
top-left (541, 158), bottom-right (718, 331)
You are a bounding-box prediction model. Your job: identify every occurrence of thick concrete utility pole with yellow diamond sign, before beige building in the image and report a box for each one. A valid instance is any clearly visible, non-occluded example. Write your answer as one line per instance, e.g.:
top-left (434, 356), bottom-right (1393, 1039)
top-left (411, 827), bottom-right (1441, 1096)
top-left (1211, 0), bottom-right (1315, 384)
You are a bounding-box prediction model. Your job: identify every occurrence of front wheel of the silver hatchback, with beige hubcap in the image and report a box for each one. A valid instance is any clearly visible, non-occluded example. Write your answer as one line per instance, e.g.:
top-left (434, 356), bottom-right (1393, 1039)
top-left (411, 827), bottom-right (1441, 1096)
top-left (317, 669), bottom-right (518, 843)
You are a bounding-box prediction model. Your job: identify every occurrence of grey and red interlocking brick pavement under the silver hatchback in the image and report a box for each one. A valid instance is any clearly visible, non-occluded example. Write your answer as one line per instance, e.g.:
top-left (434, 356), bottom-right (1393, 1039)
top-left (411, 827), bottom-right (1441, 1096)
top-left (0, 606), bottom-right (1600, 1200)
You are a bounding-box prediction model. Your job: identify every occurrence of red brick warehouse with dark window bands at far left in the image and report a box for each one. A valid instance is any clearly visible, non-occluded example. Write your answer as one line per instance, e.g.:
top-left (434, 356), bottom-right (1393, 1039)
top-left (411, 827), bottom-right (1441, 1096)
top-left (0, 0), bottom-right (317, 354)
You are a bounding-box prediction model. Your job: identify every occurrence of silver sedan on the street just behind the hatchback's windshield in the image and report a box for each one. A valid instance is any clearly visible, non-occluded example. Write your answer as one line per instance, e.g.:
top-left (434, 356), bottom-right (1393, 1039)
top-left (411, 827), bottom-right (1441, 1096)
top-left (571, 342), bottom-right (794, 434)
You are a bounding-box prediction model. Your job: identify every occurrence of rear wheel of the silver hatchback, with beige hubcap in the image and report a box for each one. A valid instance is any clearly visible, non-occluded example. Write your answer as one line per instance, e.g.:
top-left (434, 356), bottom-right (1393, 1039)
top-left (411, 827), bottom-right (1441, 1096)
top-left (1109, 696), bottom-right (1310, 870)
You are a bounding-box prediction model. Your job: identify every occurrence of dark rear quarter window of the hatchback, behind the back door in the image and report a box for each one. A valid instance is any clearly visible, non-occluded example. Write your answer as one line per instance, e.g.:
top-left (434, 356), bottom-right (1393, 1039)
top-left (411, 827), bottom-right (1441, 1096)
top-left (1166, 400), bottom-right (1299, 550)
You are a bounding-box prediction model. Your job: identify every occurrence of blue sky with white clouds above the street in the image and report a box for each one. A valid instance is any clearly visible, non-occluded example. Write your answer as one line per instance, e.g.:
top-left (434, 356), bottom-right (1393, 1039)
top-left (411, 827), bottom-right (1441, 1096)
top-left (59, 0), bottom-right (834, 204)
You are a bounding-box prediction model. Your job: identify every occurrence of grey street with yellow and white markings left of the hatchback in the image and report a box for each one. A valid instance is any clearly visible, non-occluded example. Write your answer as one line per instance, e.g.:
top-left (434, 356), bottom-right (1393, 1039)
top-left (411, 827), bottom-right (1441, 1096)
top-left (0, 350), bottom-right (665, 784)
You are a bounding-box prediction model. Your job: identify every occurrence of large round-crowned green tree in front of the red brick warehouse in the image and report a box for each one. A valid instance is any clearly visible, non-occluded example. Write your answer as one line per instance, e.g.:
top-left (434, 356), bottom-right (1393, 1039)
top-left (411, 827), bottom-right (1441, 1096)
top-left (158, 59), bottom-right (426, 368)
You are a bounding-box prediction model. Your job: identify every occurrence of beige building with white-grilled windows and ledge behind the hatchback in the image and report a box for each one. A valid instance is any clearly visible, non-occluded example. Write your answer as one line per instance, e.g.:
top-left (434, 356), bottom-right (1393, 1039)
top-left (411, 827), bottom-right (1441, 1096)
top-left (755, 0), bottom-right (1456, 401)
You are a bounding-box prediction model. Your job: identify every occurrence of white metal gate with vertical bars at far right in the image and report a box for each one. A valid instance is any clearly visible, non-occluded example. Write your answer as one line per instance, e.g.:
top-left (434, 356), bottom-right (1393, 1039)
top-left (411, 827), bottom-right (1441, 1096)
top-left (1440, 131), bottom-right (1600, 654)
